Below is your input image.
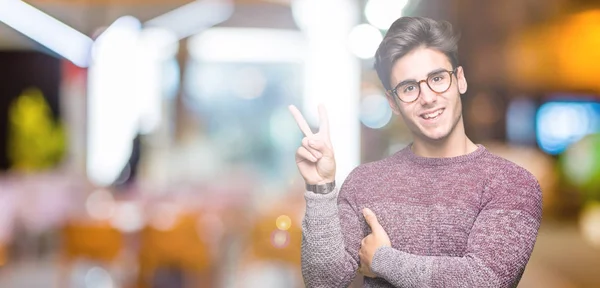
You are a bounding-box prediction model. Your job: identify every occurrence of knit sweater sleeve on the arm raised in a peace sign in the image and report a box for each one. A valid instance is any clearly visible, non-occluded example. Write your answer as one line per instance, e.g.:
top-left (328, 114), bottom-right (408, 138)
top-left (302, 172), bottom-right (365, 287)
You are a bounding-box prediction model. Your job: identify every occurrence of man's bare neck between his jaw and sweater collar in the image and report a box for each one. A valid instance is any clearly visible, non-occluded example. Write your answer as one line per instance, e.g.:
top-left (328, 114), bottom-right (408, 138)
top-left (411, 121), bottom-right (477, 158)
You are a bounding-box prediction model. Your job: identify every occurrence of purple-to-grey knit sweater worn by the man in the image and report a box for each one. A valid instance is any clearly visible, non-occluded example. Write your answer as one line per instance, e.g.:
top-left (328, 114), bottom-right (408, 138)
top-left (302, 145), bottom-right (542, 287)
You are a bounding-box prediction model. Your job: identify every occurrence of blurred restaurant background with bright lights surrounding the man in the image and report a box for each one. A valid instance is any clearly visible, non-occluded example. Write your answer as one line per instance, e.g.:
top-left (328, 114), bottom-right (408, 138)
top-left (0, 0), bottom-right (600, 287)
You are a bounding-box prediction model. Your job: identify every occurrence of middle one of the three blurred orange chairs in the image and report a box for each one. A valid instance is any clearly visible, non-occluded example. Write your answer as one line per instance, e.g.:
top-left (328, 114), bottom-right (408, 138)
top-left (138, 212), bottom-right (216, 288)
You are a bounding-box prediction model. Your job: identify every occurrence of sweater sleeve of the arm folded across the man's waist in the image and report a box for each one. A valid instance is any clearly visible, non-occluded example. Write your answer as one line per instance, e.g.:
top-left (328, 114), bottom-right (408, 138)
top-left (371, 171), bottom-right (542, 287)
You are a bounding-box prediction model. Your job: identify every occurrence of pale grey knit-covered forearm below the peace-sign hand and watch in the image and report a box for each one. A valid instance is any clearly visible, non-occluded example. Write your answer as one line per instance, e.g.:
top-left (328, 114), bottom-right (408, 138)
top-left (302, 188), bottom-right (358, 287)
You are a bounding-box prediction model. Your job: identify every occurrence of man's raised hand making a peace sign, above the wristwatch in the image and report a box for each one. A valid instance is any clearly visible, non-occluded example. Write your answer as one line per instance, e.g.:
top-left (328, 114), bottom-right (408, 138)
top-left (289, 104), bottom-right (335, 185)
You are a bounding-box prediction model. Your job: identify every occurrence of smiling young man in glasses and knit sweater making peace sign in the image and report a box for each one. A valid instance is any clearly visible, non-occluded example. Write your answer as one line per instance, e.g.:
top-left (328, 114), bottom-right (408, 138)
top-left (290, 17), bottom-right (542, 287)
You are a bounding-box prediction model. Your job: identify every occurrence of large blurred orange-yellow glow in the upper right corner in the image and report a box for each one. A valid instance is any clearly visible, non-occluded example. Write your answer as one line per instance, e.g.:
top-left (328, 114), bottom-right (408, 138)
top-left (507, 10), bottom-right (600, 91)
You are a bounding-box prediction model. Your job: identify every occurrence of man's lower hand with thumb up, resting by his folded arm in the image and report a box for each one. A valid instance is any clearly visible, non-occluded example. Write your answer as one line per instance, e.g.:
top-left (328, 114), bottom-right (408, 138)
top-left (358, 208), bottom-right (392, 278)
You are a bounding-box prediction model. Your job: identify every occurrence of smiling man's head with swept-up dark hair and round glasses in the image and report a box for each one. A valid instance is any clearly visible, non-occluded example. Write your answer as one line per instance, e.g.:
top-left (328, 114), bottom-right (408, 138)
top-left (375, 17), bottom-right (467, 141)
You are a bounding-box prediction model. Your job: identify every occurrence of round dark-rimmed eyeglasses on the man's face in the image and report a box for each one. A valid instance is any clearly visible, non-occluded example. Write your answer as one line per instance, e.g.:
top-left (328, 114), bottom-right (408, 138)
top-left (388, 68), bottom-right (456, 103)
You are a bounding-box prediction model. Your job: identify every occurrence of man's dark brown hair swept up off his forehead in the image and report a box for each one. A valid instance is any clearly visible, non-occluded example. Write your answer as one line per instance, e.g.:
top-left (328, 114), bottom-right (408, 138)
top-left (375, 17), bottom-right (460, 90)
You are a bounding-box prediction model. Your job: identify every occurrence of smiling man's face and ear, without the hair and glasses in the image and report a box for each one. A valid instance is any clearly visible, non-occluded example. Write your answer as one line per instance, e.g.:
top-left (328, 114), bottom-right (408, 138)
top-left (388, 47), bottom-right (467, 141)
